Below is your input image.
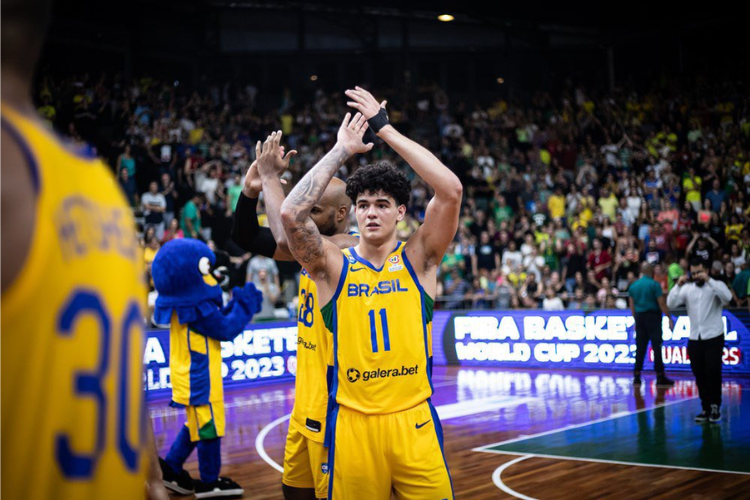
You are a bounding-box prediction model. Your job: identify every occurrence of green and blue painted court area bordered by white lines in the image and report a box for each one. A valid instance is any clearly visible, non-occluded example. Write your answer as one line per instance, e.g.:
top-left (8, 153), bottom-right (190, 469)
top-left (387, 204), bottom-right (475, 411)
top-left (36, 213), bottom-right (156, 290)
top-left (476, 392), bottom-right (750, 474)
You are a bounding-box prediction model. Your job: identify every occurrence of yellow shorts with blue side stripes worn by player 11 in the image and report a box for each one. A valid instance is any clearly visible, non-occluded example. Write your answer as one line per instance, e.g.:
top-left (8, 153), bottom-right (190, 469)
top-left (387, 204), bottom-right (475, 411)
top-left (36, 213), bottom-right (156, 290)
top-left (328, 400), bottom-right (453, 500)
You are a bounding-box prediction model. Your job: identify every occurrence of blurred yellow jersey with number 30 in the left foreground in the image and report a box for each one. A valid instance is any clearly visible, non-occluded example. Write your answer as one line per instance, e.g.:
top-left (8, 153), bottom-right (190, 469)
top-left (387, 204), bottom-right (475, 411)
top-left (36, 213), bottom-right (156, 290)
top-left (1, 104), bottom-right (150, 500)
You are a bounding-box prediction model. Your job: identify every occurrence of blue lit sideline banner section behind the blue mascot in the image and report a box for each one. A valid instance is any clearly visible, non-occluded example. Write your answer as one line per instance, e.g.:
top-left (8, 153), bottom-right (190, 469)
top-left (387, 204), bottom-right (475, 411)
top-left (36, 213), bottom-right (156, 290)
top-left (143, 321), bottom-right (298, 397)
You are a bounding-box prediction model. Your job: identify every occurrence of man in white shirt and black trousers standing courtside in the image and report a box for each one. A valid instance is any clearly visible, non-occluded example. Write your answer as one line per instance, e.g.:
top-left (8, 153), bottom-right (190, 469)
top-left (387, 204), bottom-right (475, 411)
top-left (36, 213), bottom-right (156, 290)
top-left (667, 259), bottom-right (732, 422)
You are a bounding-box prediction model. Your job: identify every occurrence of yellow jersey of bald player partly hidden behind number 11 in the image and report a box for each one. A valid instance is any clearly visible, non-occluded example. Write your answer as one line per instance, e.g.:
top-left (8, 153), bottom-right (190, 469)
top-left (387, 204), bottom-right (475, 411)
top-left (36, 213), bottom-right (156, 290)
top-left (290, 270), bottom-right (331, 443)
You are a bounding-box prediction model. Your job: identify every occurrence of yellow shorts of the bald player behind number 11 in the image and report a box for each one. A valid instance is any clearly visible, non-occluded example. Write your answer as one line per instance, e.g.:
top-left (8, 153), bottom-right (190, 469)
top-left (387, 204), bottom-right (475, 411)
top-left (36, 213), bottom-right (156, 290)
top-left (281, 424), bottom-right (328, 498)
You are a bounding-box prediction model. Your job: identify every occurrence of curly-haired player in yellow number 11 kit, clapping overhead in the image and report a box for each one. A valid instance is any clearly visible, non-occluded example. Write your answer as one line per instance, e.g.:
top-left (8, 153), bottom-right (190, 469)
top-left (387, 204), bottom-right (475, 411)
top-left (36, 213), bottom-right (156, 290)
top-left (281, 93), bottom-right (463, 500)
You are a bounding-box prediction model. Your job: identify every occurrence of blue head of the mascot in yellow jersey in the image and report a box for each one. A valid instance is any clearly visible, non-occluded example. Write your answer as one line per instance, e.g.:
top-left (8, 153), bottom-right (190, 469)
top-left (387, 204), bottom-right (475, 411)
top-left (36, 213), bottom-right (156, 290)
top-left (151, 238), bottom-right (222, 324)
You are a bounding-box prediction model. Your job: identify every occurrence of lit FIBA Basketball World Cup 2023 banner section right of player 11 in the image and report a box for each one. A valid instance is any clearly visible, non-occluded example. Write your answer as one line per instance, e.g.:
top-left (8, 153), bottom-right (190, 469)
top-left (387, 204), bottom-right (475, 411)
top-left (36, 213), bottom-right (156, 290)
top-left (433, 310), bottom-right (750, 374)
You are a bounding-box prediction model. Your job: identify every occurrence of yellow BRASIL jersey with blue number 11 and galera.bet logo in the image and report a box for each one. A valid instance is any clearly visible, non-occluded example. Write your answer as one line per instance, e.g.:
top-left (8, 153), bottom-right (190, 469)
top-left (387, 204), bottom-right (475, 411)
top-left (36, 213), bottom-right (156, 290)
top-left (321, 242), bottom-right (433, 414)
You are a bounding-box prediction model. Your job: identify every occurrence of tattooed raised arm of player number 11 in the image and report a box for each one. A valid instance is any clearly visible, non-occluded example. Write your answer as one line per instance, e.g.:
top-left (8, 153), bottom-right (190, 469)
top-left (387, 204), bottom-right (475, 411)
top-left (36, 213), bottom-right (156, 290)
top-left (280, 113), bottom-right (372, 304)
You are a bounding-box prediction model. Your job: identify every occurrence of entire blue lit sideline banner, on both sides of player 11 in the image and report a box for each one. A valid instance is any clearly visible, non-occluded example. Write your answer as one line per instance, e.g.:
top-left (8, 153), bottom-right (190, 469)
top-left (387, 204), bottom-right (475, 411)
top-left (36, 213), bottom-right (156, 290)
top-left (143, 310), bottom-right (750, 397)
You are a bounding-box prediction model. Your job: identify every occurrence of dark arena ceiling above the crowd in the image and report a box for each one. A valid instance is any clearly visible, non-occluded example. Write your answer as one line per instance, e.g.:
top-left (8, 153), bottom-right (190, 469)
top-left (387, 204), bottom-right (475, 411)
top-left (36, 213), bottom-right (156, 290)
top-left (45, 0), bottom-right (748, 98)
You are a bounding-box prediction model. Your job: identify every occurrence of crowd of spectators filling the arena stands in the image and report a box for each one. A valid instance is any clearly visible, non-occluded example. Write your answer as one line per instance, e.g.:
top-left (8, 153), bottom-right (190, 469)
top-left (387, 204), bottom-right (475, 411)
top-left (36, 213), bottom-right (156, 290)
top-left (35, 76), bottom-right (750, 318)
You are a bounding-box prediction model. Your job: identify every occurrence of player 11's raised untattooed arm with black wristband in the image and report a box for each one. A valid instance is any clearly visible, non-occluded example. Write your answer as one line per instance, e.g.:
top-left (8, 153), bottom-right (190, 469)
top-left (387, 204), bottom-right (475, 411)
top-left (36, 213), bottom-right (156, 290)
top-left (346, 87), bottom-right (463, 274)
